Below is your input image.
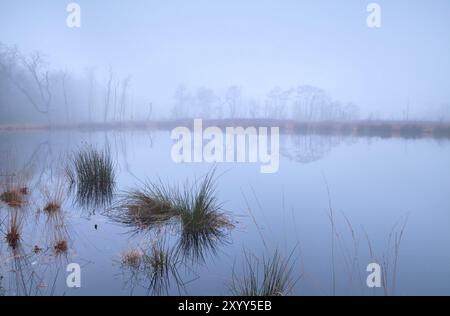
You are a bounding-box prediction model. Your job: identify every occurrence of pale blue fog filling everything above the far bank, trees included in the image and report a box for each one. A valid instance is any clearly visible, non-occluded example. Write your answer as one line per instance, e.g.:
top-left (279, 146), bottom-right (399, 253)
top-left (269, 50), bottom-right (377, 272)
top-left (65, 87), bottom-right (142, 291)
top-left (0, 0), bottom-right (450, 123)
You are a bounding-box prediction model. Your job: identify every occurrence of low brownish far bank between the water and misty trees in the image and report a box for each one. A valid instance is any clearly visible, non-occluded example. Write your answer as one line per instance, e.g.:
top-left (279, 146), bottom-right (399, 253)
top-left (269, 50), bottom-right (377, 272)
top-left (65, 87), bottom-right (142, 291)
top-left (0, 119), bottom-right (450, 139)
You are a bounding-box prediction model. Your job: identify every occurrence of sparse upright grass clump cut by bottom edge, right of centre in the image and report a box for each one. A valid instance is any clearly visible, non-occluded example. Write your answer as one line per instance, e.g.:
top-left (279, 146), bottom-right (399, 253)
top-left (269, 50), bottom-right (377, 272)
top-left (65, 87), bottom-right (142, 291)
top-left (230, 251), bottom-right (294, 296)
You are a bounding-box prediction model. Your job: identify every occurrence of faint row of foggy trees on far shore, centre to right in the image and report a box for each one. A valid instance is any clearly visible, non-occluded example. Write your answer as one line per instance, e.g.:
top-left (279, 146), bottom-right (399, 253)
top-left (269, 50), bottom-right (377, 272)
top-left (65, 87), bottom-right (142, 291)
top-left (172, 85), bottom-right (360, 121)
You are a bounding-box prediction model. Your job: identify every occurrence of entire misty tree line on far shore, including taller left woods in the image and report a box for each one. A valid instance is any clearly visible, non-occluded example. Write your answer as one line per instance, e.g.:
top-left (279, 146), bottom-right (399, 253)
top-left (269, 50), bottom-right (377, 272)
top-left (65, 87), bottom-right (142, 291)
top-left (0, 42), bottom-right (450, 124)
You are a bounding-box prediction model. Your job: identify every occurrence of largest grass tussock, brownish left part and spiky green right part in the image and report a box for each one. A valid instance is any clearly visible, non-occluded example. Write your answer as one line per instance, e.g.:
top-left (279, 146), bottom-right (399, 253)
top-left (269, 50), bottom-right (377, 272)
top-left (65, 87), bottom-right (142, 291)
top-left (111, 172), bottom-right (234, 259)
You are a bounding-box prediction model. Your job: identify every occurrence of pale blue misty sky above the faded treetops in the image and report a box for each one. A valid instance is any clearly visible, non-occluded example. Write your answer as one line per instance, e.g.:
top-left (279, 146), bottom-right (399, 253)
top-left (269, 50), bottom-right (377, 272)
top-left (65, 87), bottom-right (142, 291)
top-left (0, 0), bottom-right (450, 116)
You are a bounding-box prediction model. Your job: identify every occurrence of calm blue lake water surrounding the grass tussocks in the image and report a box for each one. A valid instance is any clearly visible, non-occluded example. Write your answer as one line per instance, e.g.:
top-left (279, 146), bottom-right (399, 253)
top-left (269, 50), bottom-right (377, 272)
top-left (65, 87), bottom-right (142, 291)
top-left (0, 131), bottom-right (450, 295)
